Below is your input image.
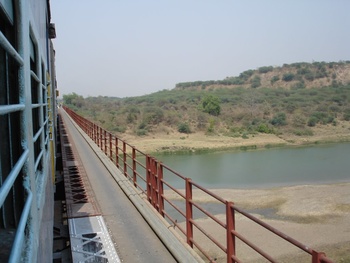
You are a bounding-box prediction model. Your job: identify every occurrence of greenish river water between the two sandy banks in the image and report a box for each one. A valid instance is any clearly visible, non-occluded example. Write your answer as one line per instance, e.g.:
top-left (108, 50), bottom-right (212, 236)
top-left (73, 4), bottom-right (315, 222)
top-left (156, 143), bottom-right (350, 189)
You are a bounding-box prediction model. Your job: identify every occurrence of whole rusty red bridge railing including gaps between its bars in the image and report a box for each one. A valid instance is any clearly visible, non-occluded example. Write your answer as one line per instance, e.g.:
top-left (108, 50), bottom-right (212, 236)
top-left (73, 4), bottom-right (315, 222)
top-left (64, 107), bottom-right (333, 263)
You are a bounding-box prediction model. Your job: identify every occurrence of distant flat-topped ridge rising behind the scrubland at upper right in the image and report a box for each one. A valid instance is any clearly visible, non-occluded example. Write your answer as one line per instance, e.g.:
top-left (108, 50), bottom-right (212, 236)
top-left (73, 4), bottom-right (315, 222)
top-left (175, 61), bottom-right (350, 90)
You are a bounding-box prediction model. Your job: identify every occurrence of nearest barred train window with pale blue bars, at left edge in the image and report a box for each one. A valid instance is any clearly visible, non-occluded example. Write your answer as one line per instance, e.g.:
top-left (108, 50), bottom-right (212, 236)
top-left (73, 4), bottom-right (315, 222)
top-left (0, 4), bottom-right (28, 261)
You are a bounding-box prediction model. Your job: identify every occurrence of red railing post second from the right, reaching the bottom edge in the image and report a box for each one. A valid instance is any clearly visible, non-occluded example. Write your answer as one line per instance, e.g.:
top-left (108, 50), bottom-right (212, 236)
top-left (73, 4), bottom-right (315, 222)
top-left (226, 202), bottom-right (236, 263)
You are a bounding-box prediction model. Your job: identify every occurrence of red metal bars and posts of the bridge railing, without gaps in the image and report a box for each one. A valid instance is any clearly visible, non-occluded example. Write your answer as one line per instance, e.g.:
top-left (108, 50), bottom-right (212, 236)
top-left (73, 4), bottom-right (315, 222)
top-left (64, 107), bottom-right (333, 263)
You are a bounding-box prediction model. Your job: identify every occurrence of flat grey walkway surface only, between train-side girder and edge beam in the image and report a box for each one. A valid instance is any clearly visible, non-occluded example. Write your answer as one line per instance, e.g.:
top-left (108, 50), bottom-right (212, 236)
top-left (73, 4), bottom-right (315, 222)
top-left (61, 111), bottom-right (176, 262)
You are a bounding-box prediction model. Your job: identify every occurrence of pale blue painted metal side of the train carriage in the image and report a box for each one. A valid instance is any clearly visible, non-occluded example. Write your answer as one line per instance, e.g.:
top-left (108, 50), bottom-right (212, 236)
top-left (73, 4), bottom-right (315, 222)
top-left (0, 0), bottom-right (56, 262)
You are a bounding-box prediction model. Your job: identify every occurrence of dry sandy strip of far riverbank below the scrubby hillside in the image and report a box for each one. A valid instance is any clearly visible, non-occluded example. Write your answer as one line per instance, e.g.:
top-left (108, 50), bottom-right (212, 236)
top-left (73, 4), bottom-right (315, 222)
top-left (121, 121), bottom-right (350, 154)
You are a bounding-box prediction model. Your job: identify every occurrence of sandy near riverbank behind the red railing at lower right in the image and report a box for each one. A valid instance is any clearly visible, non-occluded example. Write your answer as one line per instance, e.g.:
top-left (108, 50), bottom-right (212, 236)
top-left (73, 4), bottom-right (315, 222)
top-left (166, 183), bottom-right (350, 262)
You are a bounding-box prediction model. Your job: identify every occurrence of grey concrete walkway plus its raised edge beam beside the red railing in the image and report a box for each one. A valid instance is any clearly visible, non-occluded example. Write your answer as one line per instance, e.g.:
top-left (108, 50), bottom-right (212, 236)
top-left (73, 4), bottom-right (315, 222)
top-left (61, 110), bottom-right (201, 263)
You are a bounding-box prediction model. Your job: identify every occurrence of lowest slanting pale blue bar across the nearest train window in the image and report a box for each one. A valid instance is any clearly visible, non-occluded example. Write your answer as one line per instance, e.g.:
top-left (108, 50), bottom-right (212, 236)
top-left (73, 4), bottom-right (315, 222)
top-left (8, 188), bottom-right (33, 263)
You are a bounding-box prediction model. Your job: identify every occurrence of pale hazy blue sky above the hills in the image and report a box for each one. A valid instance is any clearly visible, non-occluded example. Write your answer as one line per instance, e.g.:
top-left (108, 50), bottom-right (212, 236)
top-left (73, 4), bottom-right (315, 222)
top-left (51, 0), bottom-right (350, 97)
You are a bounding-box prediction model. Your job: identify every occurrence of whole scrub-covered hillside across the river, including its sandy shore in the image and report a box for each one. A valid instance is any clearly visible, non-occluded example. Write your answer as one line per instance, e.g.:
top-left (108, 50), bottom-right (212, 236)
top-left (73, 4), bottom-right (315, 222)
top-left (63, 62), bottom-right (350, 154)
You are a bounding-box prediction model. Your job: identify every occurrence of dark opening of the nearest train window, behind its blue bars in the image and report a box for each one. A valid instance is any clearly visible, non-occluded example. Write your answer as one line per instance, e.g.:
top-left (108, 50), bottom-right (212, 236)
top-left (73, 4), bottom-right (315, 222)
top-left (0, 0), bottom-right (24, 248)
